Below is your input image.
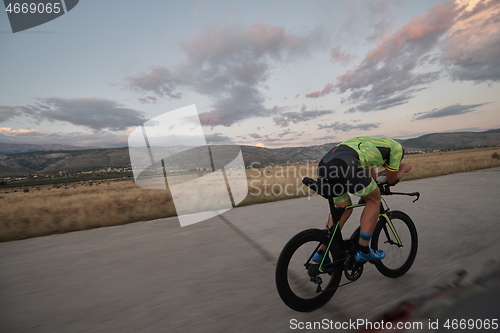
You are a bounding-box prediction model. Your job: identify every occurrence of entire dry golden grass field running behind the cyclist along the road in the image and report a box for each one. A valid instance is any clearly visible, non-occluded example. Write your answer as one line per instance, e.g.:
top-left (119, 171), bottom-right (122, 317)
top-left (0, 147), bottom-right (500, 242)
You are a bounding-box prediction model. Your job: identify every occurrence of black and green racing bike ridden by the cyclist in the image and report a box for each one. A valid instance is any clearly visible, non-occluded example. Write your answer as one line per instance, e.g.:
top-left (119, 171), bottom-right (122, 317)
top-left (275, 177), bottom-right (420, 312)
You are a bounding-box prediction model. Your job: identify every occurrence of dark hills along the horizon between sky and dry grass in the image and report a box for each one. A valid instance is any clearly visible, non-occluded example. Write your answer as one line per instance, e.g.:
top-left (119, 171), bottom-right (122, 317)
top-left (0, 129), bottom-right (500, 176)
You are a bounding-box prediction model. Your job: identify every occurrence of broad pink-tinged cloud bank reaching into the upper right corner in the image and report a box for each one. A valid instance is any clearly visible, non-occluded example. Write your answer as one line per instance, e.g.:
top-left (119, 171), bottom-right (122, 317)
top-left (306, 0), bottom-right (500, 113)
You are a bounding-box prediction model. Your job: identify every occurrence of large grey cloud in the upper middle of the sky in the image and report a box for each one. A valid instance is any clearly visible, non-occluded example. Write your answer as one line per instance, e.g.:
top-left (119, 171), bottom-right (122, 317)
top-left (124, 24), bottom-right (325, 127)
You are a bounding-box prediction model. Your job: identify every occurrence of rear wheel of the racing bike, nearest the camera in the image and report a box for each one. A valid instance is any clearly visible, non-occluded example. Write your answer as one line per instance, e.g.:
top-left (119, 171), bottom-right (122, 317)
top-left (275, 229), bottom-right (343, 312)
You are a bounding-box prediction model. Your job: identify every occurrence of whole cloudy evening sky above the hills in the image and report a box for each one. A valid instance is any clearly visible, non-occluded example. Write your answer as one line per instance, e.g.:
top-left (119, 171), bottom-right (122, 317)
top-left (0, 0), bottom-right (500, 148)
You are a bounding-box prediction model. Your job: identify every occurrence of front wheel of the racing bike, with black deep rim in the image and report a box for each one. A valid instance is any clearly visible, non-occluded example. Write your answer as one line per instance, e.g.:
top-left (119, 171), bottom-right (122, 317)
top-left (371, 211), bottom-right (418, 278)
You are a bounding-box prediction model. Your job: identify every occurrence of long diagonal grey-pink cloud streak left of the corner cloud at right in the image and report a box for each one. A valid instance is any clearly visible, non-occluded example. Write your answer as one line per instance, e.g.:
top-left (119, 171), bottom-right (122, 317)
top-left (335, 2), bottom-right (457, 107)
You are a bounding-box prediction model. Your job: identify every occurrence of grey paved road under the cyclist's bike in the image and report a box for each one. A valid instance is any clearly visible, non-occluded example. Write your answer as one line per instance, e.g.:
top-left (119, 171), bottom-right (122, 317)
top-left (0, 168), bottom-right (500, 332)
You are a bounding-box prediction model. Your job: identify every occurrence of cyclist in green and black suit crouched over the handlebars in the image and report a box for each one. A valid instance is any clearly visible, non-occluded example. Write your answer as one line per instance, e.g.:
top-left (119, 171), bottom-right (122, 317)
top-left (312, 136), bottom-right (411, 263)
